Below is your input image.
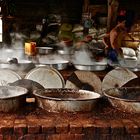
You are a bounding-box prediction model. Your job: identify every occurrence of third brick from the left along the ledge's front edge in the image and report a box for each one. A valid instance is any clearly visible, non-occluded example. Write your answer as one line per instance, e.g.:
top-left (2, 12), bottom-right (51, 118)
top-left (28, 124), bottom-right (41, 134)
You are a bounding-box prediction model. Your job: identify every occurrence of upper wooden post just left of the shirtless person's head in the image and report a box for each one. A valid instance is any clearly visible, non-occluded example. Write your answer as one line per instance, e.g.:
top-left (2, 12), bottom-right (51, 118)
top-left (107, 0), bottom-right (119, 32)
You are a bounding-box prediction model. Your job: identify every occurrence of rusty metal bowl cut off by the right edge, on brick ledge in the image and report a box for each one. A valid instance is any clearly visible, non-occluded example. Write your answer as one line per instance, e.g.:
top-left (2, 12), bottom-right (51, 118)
top-left (104, 87), bottom-right (140, 113)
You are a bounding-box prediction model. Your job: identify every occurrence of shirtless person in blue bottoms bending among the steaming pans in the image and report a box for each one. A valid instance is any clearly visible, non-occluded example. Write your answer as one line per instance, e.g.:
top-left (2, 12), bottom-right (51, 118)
top-left (103, 16), bottom-right (134, 62)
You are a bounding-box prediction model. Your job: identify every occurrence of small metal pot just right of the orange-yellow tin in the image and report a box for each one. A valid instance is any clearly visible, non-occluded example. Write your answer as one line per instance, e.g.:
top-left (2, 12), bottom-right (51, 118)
top-left (36, 47), bottom-right (53, 55)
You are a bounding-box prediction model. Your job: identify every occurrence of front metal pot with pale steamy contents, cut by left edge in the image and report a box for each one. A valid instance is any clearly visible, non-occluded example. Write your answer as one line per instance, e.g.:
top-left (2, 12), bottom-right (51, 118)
top-left (0, 86), bottom-right (28, 112)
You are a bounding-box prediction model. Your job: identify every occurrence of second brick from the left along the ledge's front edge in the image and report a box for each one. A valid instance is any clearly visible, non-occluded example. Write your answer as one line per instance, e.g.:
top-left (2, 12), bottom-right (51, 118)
top-left (14, 124), bottom-right (27, 136)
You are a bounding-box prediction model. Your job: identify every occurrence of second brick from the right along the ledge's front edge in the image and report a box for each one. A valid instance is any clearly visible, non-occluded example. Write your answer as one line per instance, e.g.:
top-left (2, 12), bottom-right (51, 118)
top-left (110, 120), bottom-right (125, 135)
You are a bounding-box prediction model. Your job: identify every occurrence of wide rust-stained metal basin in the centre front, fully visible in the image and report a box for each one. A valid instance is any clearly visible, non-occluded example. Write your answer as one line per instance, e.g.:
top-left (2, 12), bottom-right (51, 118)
top-left (34, 89), bottom-right (101, 112)
